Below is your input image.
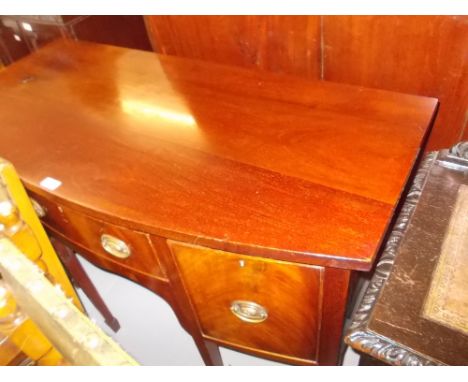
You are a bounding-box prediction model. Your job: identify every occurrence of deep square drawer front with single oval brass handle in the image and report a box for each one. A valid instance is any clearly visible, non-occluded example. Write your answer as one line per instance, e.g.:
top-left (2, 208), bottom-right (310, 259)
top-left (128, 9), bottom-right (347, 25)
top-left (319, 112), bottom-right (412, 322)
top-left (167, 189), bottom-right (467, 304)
top-left (168, 241), bottom-right (323, 361)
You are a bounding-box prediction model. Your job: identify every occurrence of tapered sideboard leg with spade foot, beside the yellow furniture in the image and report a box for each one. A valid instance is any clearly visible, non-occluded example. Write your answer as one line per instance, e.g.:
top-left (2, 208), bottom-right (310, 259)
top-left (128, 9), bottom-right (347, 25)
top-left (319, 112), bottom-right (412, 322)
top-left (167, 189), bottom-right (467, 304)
top-left (51, 238), bottom-right (120, 332)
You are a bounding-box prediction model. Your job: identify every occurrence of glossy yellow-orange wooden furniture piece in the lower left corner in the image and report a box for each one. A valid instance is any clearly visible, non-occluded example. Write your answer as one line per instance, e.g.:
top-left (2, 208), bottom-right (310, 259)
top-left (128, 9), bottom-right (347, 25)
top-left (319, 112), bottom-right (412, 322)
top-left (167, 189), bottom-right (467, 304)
top-left (0, 158), bottom-right (137, 365)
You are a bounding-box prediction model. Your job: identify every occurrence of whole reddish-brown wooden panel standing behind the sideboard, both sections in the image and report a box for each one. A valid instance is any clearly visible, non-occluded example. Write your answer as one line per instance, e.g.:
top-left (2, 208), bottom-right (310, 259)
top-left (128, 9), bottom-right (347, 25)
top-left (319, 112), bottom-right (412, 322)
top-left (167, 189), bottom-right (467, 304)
top-left (146, 16), bottom-right (468, 149)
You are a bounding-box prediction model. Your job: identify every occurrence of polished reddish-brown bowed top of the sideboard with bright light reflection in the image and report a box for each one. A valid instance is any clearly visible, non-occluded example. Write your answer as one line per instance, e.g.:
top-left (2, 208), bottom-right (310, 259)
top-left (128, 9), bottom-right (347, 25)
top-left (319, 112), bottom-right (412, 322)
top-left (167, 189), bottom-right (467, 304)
top-left (0, 41), bottom-right (437, 269)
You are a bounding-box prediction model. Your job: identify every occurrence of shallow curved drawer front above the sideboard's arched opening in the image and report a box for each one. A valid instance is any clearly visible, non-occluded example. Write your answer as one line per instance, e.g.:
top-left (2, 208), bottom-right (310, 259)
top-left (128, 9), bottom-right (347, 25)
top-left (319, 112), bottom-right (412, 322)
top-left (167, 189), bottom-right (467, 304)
top-left (29, 192), bottom-right (165, 279)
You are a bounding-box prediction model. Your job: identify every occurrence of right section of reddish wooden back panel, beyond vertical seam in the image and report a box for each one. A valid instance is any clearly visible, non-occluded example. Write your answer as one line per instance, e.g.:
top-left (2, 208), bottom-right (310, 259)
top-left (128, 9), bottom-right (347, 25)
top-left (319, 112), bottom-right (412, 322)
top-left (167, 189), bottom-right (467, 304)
top-left (323, 16), bottom-right (468, 149)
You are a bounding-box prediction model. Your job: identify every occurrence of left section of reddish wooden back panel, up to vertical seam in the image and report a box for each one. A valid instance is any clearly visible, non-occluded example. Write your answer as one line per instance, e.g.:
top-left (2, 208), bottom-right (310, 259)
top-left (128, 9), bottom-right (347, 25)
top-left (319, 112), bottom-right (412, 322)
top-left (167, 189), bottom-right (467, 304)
top-left (145, 16), bottom-right (320, 79)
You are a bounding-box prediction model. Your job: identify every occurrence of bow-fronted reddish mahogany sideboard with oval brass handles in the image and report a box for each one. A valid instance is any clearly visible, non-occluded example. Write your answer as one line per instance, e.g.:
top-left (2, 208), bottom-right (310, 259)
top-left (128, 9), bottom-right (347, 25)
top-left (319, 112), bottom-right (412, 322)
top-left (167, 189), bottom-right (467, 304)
top-left (0, 40), bottom-right (438, 365)
